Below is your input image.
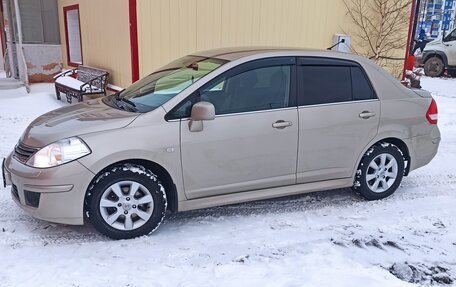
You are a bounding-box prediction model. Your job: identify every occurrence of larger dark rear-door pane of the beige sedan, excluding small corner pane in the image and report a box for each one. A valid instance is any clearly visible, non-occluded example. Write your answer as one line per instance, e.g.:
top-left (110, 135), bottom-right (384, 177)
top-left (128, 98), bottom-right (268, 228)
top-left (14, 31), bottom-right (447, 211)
top-left (298, 66), bottom-right (352, 105)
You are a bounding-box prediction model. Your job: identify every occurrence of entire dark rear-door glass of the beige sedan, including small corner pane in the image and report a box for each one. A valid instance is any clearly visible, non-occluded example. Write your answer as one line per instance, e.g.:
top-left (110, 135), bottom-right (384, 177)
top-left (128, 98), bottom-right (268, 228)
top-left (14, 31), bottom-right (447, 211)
top-left (298, 59), bottom-right (375, 106)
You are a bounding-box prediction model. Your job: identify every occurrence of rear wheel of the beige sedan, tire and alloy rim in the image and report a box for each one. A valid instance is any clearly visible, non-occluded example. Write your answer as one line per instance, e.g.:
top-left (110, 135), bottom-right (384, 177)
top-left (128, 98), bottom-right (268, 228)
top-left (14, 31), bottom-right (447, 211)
top-left (353, 143), bottom-right (405, 200)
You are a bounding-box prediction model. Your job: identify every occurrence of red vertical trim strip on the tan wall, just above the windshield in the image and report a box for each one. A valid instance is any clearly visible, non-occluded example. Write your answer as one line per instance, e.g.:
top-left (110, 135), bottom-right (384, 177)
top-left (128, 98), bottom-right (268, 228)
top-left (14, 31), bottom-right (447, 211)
top-left (128, 0), bottom-right (139, 83)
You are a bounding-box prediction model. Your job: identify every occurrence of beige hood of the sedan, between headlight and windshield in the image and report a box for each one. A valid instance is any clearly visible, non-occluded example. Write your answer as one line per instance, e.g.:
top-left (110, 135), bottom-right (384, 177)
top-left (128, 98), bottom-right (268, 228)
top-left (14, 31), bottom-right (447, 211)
top-left (21, 99), bottom-right (140, 147)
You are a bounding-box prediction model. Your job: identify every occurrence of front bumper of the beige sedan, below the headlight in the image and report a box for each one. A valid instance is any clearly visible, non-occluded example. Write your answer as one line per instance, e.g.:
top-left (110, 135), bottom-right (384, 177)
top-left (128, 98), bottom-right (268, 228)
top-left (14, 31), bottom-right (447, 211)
top-left (2, 155), bottom-right (94, 225)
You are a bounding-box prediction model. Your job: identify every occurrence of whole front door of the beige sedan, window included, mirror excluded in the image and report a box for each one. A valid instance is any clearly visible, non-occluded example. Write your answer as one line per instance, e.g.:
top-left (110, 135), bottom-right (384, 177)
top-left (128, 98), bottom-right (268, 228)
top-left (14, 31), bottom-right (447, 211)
top-left (177, 57), bottom-right (298, 199)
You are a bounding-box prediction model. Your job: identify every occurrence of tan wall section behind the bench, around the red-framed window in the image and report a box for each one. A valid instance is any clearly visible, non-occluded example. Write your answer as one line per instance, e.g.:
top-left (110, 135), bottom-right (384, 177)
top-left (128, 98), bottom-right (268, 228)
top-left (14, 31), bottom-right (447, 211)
top-left (58, 0), bottom-right (131, 87)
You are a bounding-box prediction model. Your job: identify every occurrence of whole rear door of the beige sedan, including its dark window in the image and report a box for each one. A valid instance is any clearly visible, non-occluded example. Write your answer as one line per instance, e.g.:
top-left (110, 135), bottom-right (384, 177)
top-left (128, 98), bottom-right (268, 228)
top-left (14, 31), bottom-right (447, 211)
top-left (297, 58), bottom-right (380, 183)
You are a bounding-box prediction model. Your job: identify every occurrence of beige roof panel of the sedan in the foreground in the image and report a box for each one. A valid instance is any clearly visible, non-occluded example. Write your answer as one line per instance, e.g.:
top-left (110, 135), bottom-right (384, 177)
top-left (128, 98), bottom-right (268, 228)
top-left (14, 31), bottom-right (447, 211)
top-left (192, 47), bottom-right (370, 63)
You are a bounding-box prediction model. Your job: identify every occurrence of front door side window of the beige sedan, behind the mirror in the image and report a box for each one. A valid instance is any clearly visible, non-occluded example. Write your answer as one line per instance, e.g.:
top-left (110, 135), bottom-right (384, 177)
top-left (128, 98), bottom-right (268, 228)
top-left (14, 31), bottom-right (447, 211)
top-left (170, 59), bottom-right (292, 119)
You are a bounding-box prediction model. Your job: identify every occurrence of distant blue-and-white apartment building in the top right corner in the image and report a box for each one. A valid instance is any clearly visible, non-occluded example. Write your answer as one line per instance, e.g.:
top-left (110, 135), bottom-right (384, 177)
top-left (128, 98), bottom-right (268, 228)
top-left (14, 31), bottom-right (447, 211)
top-left (416, 0), bottom-right (456, 39)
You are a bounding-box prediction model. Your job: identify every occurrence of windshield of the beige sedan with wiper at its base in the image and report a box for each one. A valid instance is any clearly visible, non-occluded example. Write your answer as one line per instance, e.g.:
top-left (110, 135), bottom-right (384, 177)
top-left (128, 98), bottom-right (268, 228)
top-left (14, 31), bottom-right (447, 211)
top-left (103, 56), bottom-right (227, 112)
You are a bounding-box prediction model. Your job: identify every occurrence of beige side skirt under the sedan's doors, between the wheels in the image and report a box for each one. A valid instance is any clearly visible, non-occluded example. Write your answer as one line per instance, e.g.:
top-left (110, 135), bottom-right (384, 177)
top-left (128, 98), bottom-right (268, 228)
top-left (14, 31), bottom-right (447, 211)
top-left (178, 177), bottom-right (353, 211)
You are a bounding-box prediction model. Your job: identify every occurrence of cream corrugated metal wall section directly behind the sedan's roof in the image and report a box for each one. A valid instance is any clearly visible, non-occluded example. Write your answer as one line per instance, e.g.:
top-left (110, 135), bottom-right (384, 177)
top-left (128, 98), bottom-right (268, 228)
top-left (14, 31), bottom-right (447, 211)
top-left (138, 0), bottom-right (358, 76)
